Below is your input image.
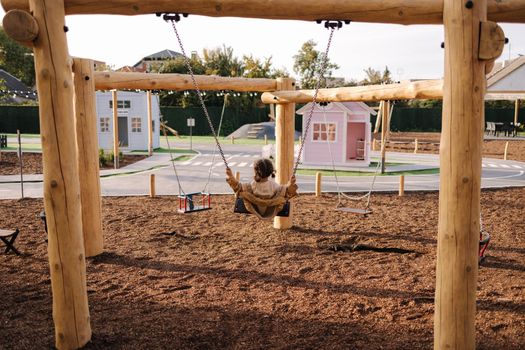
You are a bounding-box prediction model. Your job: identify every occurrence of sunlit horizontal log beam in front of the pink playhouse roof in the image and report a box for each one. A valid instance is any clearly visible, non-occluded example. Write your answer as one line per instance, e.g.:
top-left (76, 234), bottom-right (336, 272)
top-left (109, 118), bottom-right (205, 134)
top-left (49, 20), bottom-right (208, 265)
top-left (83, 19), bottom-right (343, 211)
top-left (261, 80), bottom-right (443, 104)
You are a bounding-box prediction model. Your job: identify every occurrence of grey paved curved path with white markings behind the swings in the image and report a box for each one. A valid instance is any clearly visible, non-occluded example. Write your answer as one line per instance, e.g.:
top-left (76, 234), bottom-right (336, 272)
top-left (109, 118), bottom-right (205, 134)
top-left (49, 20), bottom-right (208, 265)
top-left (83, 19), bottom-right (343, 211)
top-left (0, 144), bottom-right (525, 199)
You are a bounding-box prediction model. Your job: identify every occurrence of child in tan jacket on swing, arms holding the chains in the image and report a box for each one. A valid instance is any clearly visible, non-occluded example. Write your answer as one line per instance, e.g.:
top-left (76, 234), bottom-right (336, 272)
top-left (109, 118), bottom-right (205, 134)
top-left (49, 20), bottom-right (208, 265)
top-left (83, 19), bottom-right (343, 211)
top-left (226, 158), bottom-right (297, 219)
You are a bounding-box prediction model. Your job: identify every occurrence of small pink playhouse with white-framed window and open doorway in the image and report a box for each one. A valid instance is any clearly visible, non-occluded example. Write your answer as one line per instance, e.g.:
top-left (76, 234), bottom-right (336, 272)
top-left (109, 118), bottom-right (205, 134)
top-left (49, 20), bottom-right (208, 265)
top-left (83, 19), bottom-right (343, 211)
top-left (296, 102), bottom-right (377, 168)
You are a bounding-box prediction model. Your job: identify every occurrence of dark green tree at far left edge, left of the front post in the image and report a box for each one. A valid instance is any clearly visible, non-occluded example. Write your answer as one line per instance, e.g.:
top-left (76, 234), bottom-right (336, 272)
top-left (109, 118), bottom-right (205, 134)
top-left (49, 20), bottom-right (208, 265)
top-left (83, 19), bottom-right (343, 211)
top-left (0, 27), bottom-right (35, 87)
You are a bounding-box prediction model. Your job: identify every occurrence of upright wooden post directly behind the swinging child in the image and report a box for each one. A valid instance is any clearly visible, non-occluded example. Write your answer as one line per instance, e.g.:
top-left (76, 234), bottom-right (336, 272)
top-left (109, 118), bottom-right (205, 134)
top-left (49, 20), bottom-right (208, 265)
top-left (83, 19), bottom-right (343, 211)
top-left (273, 78), bottom-right (295, 229)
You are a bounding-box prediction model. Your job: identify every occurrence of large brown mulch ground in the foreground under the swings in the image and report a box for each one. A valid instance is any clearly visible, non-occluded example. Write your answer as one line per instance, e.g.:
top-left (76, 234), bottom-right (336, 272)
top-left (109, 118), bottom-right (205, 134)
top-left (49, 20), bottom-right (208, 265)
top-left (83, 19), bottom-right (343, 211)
top-left (0, 188), bottom-right (525, 349)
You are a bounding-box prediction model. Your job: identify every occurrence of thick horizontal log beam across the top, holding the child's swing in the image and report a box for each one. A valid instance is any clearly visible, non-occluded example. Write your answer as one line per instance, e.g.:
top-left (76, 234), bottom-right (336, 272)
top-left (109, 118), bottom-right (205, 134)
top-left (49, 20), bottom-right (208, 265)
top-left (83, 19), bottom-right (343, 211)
top-left (2, 0), bottom-right (525, 24)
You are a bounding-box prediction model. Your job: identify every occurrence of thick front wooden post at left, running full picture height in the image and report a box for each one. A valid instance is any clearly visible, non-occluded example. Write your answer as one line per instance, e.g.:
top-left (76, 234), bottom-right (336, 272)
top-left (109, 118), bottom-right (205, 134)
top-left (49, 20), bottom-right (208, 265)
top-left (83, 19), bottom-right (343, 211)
top-left (29, 0), bottom-right (91, 349)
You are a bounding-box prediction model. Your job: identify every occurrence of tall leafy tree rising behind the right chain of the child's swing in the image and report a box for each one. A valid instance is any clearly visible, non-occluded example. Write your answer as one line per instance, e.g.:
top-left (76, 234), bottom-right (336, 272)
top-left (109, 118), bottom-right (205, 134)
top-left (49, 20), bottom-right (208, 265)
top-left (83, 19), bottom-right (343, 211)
top-left (293, 40), bottom-right (339, 89)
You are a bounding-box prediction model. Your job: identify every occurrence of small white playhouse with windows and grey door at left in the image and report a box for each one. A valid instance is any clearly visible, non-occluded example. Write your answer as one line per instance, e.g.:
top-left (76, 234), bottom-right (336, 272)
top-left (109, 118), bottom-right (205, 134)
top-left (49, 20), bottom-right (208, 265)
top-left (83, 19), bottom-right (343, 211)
top-left (97, 91), bottom-right (160, 151)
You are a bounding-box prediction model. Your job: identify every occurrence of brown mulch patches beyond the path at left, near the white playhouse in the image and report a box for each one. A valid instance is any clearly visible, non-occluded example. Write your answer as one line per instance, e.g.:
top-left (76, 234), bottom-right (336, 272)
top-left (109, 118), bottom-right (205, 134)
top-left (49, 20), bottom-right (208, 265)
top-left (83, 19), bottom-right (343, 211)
top-left (0, 152), bottom-right (147, 175)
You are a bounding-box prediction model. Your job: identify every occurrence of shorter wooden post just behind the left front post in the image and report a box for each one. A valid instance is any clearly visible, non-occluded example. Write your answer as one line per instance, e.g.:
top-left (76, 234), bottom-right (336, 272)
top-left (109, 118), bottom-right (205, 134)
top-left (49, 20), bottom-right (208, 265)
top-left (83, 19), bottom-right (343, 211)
top-left (73, 58), bottom-right (104, 257)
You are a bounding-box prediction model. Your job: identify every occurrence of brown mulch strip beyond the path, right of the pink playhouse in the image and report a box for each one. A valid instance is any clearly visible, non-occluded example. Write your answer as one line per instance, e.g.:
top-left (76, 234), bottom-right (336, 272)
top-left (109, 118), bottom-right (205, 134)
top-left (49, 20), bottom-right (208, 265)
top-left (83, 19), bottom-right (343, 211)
top-left (375, 132), bottom-right (525, 162)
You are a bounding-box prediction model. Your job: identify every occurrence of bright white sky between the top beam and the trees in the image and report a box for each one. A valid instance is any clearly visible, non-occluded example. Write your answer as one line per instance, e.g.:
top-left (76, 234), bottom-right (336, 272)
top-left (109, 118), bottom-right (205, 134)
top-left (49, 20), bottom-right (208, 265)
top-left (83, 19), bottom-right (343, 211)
top-left (1, 12), bottom-right (525, 80)
